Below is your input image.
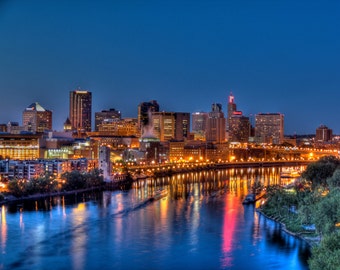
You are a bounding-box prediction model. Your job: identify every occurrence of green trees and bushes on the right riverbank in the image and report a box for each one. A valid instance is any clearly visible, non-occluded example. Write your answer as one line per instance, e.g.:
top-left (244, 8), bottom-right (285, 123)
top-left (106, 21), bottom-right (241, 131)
top-left (256, 156), bottom-right (340, 270)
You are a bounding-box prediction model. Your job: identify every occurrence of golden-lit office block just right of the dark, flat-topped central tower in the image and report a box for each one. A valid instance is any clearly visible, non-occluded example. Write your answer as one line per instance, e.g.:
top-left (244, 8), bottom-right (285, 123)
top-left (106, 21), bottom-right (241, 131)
top-left (152, 112), bottom-right (175, 141)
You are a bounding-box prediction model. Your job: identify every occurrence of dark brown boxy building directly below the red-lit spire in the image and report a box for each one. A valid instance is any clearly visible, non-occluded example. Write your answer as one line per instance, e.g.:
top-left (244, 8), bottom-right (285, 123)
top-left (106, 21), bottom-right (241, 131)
top-left (229, 115), bottom-right (251, 143)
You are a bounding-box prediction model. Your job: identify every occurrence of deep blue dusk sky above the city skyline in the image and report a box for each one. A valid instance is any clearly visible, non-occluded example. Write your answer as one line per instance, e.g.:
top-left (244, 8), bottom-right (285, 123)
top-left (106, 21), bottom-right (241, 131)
top-left (0, 0), bottom-right (340, 134)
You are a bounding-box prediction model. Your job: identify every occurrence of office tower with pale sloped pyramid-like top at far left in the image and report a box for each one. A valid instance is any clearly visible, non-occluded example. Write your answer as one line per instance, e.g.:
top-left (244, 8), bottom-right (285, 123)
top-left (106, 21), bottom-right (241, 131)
top-left (22, 102), bottom-right (52, 133)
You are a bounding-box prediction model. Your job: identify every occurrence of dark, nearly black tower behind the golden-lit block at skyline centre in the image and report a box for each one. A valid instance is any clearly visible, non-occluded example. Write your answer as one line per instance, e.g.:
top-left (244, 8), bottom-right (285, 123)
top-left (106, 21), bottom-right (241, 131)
top-left (138, 100), bottom-right (159, 137)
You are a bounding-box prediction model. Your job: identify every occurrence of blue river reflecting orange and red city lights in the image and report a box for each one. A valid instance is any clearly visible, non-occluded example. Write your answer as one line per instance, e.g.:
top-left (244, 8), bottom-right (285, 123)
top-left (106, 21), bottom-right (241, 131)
top-left (0, 168), bottom-right (309, 270)
